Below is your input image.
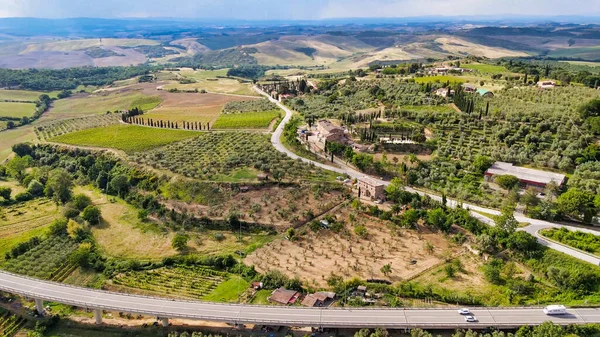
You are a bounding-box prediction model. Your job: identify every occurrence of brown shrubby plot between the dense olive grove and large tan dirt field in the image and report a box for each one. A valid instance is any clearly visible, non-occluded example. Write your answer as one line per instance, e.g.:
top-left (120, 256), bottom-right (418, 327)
top-left (167, 186), bottom-right (343, 230)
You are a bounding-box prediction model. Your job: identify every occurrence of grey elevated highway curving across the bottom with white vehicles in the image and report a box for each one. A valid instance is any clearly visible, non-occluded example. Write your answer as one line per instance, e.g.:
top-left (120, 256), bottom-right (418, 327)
top-left (0, 272), bottom-right (600, 329)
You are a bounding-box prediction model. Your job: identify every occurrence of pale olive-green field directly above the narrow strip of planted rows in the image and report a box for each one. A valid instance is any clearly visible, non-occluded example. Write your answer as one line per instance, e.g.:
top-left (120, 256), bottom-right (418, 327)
top-left (48, 93), bottom-right (162, 117)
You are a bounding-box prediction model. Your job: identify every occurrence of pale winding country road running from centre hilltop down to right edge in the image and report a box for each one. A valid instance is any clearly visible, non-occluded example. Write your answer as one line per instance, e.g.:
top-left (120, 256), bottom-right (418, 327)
top-left (254, 86), bottom-right (600, 265)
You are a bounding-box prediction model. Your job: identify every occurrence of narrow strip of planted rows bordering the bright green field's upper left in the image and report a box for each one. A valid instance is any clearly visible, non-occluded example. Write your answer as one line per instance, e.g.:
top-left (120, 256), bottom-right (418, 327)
top-left (35, 114), bottom-right (121, 140)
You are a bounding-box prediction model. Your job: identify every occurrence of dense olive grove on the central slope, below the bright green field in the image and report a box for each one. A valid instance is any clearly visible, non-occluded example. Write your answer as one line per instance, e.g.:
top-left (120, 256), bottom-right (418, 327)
top-left (133, 132), bottom-right (330, 181)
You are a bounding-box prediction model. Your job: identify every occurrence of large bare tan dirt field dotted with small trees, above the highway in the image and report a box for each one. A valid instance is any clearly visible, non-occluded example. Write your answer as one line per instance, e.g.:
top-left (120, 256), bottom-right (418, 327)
top-left (244, 208), bottom-right (461, 287)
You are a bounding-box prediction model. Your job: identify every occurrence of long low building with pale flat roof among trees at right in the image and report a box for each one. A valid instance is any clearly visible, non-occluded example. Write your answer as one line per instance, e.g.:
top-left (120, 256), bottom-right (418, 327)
top-left (485, 161), bottom-right (565, 192)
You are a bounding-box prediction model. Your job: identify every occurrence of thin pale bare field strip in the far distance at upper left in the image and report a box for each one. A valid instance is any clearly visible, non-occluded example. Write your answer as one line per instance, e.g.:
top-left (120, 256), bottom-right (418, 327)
top-left (21, 39), bottom-right (158, 54)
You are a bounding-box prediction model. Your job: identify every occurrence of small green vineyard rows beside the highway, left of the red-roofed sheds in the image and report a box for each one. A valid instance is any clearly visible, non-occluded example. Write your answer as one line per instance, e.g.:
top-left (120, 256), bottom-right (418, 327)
top-left (112, 265), bottom-right (228, 299)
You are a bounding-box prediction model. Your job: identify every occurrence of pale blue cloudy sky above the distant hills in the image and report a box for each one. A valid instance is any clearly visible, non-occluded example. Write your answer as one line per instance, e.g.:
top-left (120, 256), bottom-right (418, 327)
top-left (0, 0), bottom-right (600, 20)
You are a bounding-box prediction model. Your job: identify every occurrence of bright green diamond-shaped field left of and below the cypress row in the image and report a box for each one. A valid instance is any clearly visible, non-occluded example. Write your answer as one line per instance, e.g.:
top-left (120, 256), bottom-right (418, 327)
top-left (50, 124), bottom-right (198, 152)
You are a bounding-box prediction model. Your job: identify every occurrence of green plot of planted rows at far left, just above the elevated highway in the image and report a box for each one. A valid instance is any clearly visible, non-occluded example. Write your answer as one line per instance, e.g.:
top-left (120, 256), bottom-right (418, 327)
top-left (4, 237), bottom-right (77, 281)
